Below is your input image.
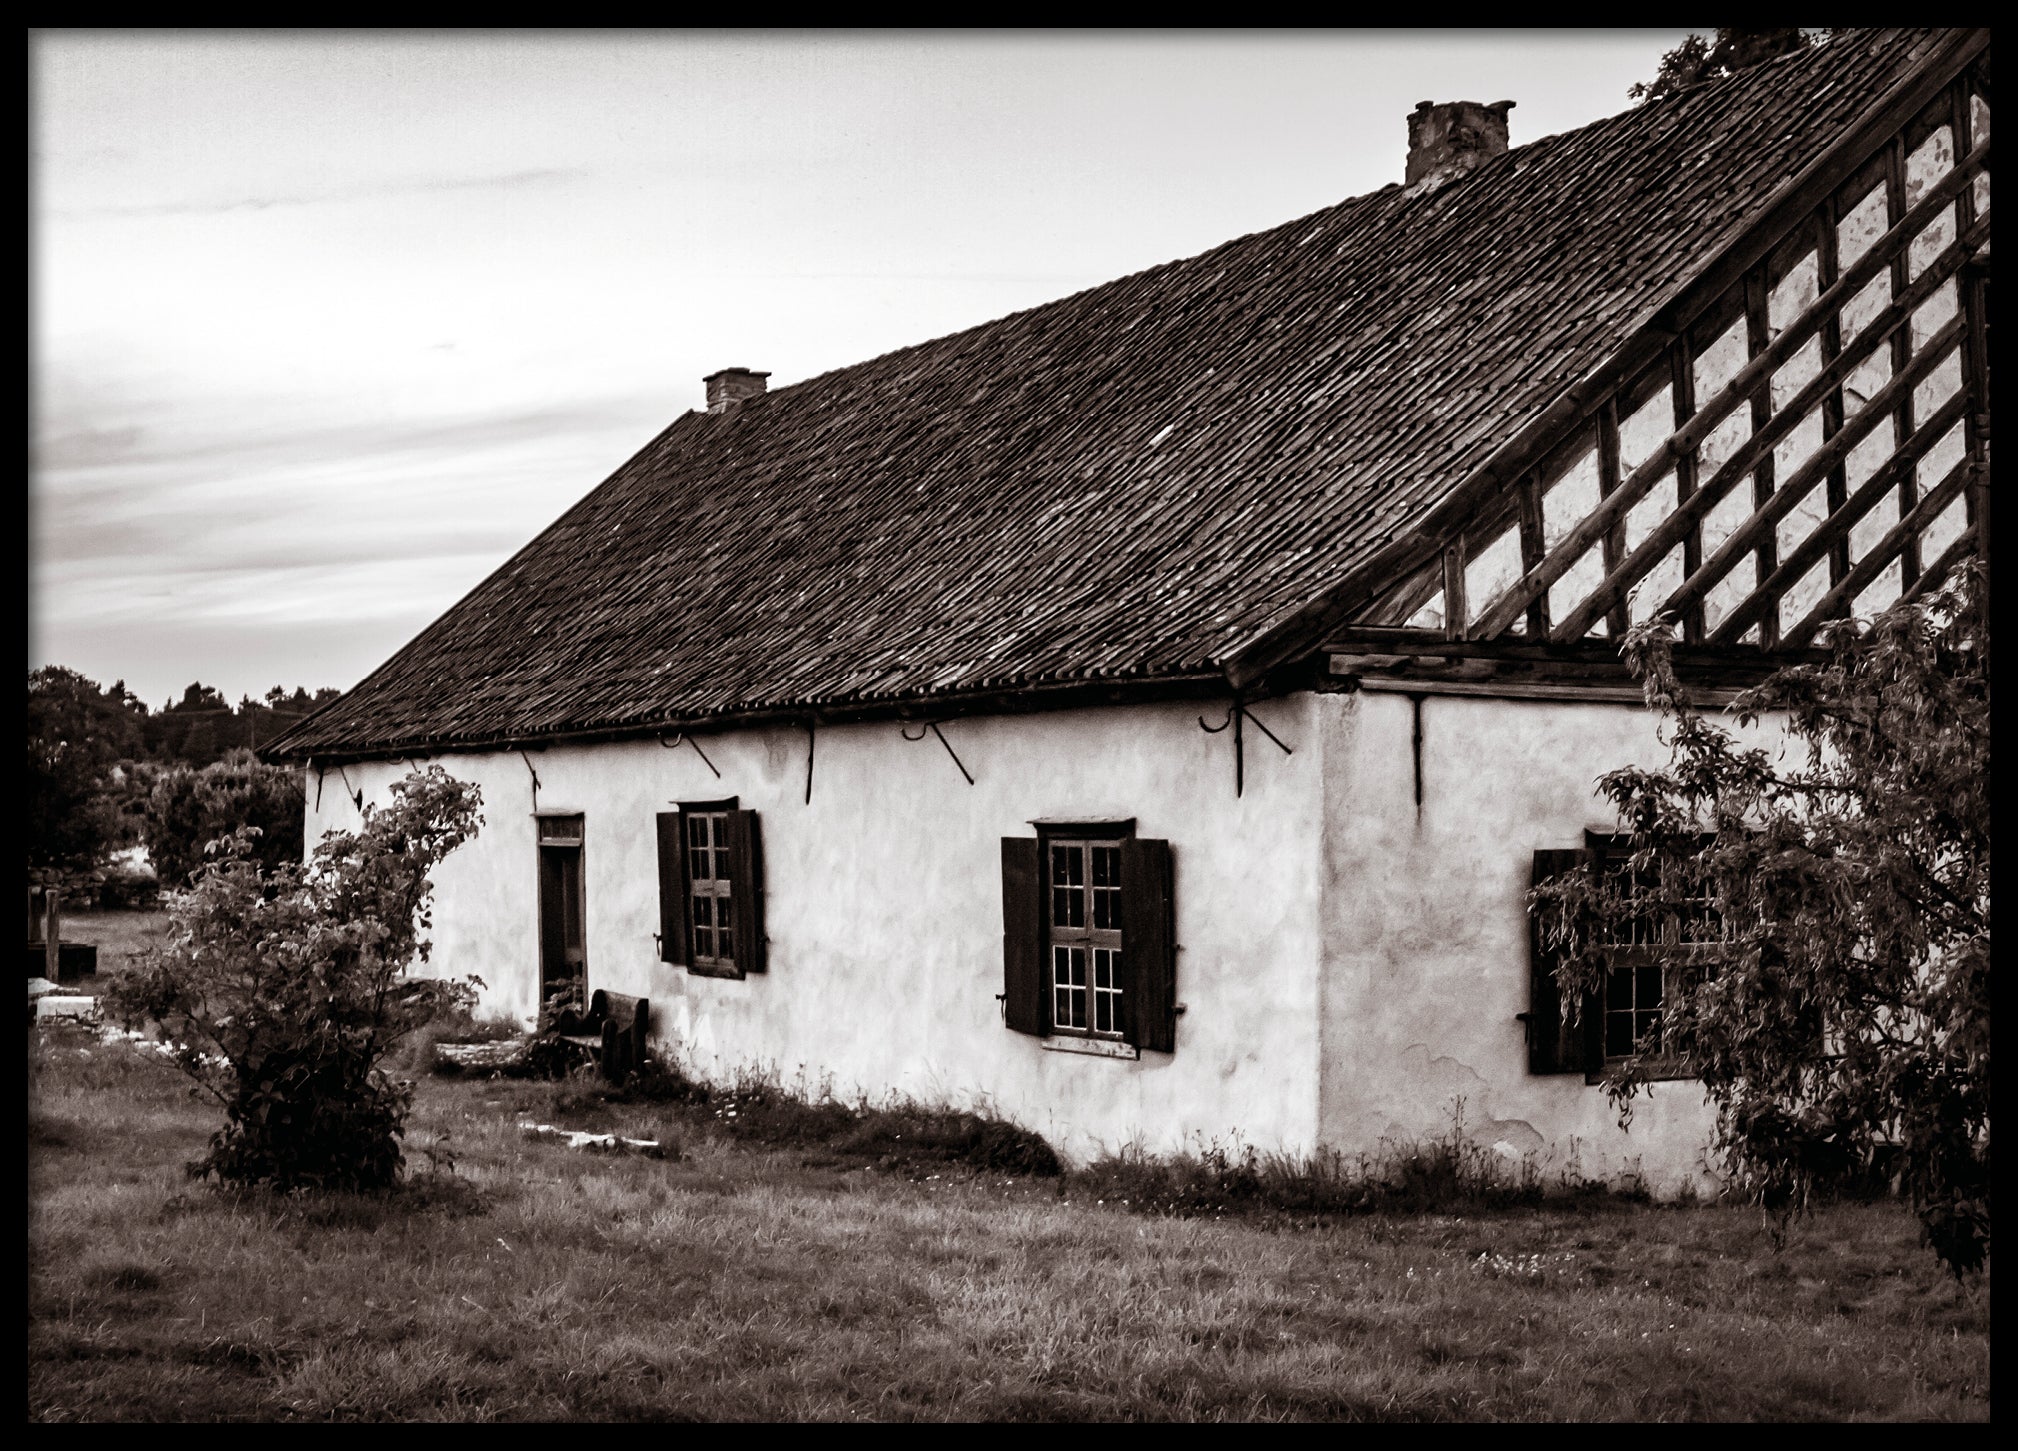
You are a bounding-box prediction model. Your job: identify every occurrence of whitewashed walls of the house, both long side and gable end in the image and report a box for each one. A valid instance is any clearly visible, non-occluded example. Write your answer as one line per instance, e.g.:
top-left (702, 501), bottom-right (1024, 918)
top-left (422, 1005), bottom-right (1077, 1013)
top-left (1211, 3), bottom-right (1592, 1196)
top-left (309, 692), bottom-right (1791, 1193)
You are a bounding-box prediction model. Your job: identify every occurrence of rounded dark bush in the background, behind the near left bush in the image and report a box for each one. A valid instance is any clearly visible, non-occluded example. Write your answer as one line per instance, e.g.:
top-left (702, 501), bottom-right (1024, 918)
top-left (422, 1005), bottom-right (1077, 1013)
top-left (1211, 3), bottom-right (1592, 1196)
top-left (143, 751), bottom-right (303, 888)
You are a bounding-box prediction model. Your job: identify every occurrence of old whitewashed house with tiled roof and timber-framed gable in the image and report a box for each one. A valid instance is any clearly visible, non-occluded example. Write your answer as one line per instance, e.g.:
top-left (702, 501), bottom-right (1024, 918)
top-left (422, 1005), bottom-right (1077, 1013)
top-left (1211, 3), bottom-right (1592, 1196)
top-left (270, 30), bottom-right (1990, 1185)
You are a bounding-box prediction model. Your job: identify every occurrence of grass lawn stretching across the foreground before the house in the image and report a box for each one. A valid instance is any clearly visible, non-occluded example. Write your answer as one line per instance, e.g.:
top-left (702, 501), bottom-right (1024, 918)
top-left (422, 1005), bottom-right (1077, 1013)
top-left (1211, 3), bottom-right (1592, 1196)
top-left (28, 1027), bottom-right (1990, 1421)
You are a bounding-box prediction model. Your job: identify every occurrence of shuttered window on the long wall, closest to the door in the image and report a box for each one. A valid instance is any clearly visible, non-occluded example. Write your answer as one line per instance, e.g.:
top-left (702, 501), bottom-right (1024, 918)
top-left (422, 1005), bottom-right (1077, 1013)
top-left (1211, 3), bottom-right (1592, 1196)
top-left (658, 797), bottom-right (765, 977)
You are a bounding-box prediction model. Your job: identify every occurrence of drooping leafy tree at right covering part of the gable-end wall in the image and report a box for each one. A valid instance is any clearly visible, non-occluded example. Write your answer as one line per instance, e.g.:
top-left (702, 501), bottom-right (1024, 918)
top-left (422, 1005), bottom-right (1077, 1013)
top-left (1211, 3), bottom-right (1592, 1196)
top-left (1532, 563), bottom-right (1990, 1273)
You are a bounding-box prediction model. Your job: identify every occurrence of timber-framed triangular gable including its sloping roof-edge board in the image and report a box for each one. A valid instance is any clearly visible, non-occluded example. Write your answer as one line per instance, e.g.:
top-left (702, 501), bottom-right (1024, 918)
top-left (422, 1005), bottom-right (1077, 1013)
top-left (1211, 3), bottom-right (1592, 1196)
top-left (1227, 30), bottom-right (1990, 684)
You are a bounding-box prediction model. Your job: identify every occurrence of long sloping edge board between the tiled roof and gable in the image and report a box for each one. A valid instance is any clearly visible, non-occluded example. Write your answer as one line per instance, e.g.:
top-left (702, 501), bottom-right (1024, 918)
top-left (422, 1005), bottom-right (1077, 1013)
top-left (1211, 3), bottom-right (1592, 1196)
top-left (1227, 28), bottom-right (1990, 686)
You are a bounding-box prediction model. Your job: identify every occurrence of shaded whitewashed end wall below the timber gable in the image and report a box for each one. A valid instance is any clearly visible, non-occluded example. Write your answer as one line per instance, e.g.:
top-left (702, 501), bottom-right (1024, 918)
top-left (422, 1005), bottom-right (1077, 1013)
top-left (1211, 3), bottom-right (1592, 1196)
top-left (1320, 692), bottom-right (1759, 1193)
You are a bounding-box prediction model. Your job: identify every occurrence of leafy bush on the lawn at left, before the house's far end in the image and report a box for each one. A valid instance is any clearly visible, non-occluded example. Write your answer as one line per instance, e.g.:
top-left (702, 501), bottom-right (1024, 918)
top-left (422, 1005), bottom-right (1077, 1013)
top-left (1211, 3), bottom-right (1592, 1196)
top-left (103, 767), bottom-right (482, 1189)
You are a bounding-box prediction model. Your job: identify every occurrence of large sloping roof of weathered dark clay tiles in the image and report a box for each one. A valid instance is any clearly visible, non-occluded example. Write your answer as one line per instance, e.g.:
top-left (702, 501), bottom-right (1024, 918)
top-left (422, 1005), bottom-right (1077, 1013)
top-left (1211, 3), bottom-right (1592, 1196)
top-left (270, 32), bottom-right (1953, 759)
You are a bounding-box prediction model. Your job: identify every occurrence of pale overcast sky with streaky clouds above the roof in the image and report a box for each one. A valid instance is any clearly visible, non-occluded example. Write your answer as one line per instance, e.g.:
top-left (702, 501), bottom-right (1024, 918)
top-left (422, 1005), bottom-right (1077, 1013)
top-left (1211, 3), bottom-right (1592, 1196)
top-left (28, 30), bottom-right (1679, 704)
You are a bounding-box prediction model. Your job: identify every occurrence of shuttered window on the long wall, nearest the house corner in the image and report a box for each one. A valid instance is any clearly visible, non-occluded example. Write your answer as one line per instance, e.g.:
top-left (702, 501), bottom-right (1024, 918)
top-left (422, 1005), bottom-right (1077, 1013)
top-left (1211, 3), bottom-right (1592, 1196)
top-left (1003, 821), bottom-right (1176, 1053)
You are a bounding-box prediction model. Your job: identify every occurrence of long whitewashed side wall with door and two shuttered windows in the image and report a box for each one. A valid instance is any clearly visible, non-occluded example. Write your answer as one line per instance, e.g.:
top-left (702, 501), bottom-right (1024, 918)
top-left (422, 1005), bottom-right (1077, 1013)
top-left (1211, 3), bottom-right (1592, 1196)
top-left (307, 694), bottom-right (1336, 1158)
